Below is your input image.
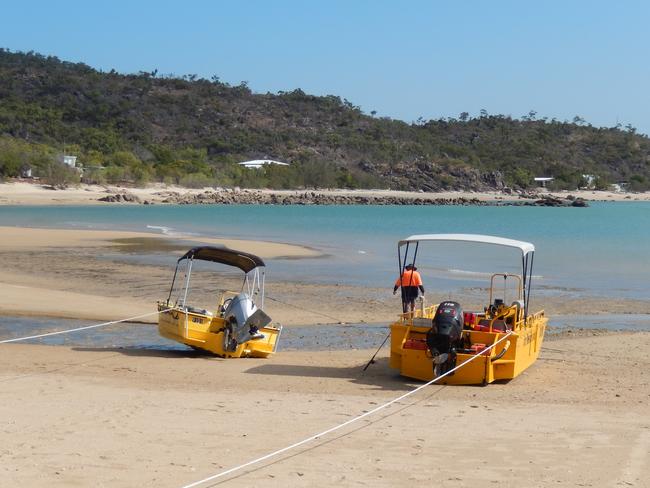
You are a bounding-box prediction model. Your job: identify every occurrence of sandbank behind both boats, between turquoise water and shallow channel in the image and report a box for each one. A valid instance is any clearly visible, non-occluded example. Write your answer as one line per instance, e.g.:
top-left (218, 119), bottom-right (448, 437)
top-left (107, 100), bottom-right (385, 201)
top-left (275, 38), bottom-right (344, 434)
top-left (0, 227), bottom-right (650, 326)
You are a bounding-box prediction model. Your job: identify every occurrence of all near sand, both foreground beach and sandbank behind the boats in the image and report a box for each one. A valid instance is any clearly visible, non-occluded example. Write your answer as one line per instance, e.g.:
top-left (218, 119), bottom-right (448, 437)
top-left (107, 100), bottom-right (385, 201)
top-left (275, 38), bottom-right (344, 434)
top-left (0, 223), bottom-right (650, 487)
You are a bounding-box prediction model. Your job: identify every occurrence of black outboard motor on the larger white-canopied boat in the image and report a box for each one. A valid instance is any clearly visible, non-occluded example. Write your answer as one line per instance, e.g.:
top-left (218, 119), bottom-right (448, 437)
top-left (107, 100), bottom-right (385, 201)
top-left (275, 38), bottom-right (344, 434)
top-left (427, 302), bottom-right (463, 376)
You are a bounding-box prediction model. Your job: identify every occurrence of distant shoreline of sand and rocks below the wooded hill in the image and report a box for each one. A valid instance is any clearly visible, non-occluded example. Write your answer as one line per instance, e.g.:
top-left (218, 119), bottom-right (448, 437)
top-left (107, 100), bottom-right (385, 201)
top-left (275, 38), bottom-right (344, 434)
top-left (0, 181), bottom-right (650, 206)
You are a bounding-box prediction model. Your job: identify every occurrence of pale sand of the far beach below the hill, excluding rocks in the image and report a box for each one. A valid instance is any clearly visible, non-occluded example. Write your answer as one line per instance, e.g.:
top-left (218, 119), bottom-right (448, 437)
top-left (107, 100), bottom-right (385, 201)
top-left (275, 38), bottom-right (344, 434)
top-left (0, 182), bottom-right (650, 205)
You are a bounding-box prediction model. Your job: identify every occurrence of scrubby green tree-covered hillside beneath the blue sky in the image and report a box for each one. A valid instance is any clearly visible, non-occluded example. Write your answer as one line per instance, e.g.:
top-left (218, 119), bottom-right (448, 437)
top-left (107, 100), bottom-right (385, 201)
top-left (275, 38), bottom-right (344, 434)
top-left (0, 49), bottom-right (650, 191)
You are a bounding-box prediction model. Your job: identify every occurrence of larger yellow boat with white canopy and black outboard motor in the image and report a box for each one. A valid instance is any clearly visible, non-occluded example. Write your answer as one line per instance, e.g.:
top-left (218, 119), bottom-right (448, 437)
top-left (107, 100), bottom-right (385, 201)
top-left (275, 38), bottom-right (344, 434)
top-left (390, 234), bottom-right (548, 385)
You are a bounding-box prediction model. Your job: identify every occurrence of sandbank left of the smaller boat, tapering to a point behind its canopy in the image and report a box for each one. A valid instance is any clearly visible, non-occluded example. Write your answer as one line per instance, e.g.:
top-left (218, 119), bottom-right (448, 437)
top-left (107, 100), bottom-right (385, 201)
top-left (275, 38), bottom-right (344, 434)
top-left (0, 226), bottom-right (323, 322)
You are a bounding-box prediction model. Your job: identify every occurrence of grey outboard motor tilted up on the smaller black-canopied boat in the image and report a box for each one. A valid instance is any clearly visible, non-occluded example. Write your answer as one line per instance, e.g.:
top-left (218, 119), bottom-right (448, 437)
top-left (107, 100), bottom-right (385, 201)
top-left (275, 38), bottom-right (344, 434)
top-left (223, 293), bottom-right (271, 351)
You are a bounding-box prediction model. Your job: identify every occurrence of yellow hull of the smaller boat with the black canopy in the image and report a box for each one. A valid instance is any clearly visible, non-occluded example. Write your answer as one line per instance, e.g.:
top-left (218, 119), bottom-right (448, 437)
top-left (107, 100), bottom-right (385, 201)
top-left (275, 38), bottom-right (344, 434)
top-left (158, 303), bottom-right (282, 358)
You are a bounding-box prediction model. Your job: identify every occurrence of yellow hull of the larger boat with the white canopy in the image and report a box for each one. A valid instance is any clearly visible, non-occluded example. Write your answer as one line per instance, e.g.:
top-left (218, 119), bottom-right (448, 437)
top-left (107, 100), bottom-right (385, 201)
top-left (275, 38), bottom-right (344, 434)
top-left (390, 307), bottom-right (548, 385)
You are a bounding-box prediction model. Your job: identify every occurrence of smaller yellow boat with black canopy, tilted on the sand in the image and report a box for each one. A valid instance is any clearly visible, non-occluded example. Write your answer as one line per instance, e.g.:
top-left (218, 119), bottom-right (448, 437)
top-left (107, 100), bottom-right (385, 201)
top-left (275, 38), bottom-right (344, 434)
top-left (158, 246), bottom-right (282, 358)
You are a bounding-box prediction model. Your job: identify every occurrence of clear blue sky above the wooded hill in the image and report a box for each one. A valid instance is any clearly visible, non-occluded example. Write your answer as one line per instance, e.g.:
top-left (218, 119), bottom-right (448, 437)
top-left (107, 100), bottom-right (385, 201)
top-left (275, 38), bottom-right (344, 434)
top-left (0, 0), bottom-right (650, 134)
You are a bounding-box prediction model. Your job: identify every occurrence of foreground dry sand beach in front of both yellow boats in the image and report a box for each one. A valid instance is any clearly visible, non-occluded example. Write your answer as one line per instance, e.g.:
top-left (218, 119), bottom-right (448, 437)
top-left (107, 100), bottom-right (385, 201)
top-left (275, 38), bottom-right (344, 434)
top-left (0, 333), bottom-right (650, 487)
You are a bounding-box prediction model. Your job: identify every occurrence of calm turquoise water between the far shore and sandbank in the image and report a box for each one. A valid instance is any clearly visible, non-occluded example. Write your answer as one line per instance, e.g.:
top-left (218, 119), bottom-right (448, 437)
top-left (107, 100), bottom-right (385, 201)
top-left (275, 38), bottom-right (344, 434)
top-left (0, 202), bottom-right (650, 299)
